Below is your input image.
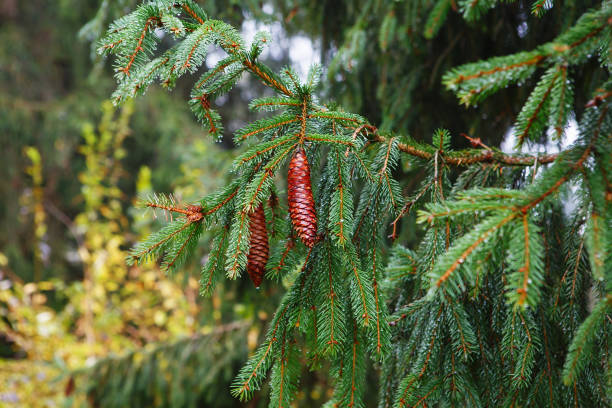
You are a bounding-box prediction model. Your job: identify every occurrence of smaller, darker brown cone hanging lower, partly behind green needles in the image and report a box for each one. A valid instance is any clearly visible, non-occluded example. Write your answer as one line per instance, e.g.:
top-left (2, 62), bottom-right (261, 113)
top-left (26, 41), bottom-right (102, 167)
top-left (247, 204), bottom-right (268, 288)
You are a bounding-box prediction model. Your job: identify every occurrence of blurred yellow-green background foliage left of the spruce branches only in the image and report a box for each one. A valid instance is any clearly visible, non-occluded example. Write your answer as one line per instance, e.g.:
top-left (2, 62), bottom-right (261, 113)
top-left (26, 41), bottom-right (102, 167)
top-left (0, 0), bottom-right (279, 407)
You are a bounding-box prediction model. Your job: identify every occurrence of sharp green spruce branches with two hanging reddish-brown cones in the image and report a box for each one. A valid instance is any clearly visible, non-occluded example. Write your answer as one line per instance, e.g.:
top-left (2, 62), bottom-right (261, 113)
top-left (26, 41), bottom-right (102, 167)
top-left (100, 0), bottom-right (612, 407)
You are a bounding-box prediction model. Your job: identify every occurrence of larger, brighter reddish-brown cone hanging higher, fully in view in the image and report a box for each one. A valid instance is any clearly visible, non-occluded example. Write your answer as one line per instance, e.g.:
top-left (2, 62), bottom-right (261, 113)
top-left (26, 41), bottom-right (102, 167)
top-left (287, 147), bottom-right (317, 248)
